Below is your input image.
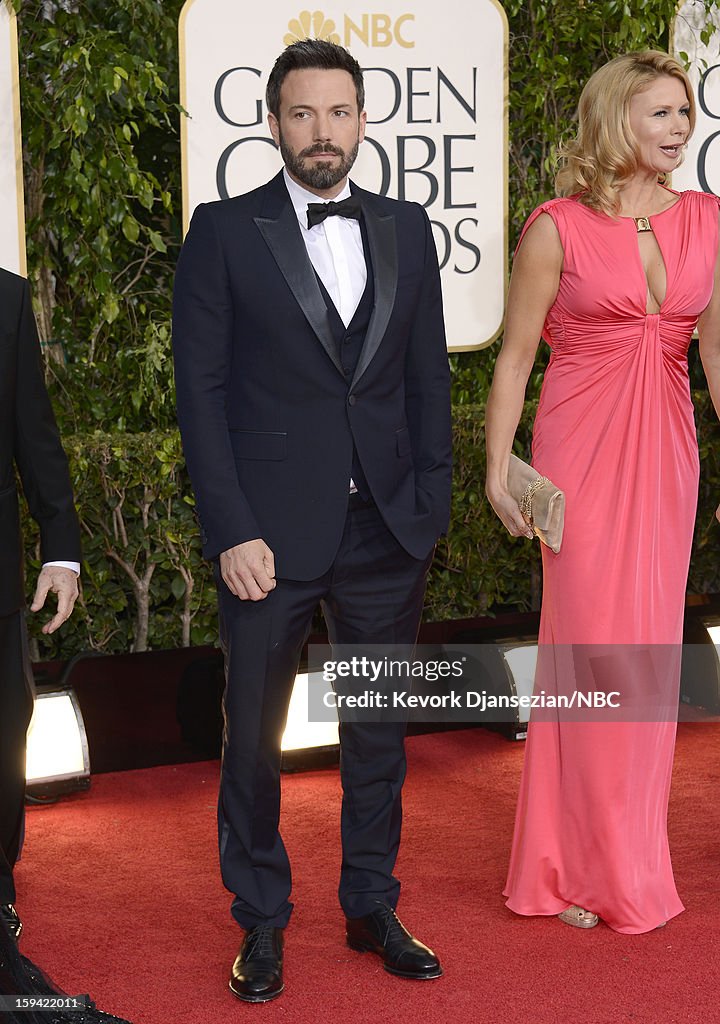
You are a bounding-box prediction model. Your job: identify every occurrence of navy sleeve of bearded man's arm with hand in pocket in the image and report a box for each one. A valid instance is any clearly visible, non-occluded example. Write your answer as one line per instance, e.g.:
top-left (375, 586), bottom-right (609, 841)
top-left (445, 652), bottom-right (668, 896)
top-left (405, 207), bottom-right (453, 535)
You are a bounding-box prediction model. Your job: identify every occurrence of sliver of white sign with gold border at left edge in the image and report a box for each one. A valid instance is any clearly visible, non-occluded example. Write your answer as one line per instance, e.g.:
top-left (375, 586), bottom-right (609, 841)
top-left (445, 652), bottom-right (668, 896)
top-left (0, 0), bottom-right (26, 274)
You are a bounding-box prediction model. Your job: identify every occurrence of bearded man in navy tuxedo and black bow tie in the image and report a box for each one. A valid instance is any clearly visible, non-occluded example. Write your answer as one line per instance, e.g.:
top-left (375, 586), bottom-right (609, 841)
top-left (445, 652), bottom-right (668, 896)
top-left (173, 40), bottom-right (451, 1002)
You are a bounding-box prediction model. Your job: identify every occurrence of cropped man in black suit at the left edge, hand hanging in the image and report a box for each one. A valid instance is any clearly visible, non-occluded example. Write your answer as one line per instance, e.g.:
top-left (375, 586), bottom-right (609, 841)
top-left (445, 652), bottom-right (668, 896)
top-left (0, 269), bottom-right (80, 938)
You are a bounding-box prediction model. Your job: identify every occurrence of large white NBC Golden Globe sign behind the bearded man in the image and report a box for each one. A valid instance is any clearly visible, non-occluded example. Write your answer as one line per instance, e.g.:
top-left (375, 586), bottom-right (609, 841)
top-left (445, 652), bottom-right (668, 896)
top-left (180, 0), bottom-right (507, 350)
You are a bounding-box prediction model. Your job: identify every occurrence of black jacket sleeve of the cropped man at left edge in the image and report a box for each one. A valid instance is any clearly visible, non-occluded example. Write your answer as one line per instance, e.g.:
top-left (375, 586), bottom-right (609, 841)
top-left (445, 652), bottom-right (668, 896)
top-left (13, 281), bottom-right (81, 562)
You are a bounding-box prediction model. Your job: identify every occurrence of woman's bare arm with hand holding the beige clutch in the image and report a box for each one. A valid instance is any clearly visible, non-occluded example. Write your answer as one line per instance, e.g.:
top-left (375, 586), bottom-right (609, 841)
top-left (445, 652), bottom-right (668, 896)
top-left (485, 214), bottom-right (565, 538)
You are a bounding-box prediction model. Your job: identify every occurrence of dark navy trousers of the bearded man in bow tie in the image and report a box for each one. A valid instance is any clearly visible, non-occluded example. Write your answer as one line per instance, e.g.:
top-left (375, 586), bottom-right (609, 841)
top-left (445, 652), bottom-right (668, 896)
top-left (218, 497), bottom-right (432, 928)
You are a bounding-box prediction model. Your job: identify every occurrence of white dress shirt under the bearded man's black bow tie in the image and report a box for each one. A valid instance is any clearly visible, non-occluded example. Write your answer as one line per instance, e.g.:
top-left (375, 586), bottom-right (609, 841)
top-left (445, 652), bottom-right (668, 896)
top-left (283, 168), bottom-right (368, 327)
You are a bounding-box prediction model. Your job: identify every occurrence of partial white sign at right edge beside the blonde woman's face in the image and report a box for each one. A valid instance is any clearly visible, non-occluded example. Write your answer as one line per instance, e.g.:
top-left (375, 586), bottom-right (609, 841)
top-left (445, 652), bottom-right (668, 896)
top-left (672, 0), bottom-right (720, 196)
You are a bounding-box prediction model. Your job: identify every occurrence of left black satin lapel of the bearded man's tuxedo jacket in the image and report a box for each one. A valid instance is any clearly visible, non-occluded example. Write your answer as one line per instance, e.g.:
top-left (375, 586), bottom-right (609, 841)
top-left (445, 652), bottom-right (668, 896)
top-left (253, 200), bottom-right (344, 376)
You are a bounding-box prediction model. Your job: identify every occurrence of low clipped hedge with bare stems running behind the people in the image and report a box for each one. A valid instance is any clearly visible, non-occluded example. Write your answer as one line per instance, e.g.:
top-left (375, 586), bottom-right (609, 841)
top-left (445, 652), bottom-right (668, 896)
top-left (25, 392), bottom-right (720, 658)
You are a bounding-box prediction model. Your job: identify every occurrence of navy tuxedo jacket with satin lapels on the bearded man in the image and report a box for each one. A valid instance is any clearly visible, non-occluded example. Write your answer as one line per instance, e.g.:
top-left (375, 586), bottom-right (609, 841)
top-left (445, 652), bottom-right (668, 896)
top-left (173, 172), bottom-right (451, 580)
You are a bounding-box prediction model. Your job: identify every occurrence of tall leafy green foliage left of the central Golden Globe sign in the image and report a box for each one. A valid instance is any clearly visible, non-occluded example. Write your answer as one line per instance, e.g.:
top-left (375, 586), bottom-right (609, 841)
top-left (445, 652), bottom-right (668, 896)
top-left (15, 0), bottom-right (180, 431)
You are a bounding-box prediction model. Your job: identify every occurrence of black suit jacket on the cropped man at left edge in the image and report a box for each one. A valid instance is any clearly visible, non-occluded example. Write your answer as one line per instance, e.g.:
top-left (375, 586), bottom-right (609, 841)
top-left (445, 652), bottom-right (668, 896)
top-left (0, 269), bottom-right (81, 615)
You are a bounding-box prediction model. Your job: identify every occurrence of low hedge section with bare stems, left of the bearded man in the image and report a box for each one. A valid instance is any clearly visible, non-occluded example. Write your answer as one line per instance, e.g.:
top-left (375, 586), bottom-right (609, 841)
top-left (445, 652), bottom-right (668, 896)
top-left (25, 431), bottom-right (217, 657)
